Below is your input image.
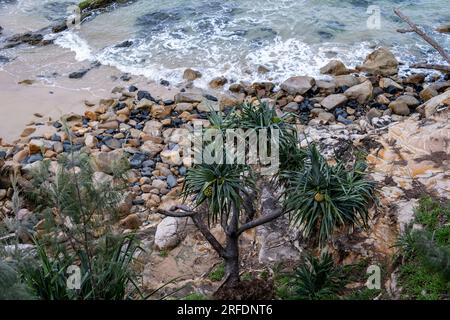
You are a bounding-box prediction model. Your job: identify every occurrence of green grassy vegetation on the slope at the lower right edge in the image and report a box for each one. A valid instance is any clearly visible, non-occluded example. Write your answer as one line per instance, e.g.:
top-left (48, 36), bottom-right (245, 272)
top-left (397, 197), bottom-right (450, 300)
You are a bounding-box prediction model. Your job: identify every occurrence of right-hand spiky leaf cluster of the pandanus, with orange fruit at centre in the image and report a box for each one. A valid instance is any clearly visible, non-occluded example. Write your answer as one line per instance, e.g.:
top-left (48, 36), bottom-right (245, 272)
top-left (281, 145), bottom-right (374, 244)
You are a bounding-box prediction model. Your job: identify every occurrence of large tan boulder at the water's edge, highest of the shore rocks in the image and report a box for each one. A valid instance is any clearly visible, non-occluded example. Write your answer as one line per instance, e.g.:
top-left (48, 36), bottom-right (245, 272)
top-left (357, 48), bottom-right (398, 76)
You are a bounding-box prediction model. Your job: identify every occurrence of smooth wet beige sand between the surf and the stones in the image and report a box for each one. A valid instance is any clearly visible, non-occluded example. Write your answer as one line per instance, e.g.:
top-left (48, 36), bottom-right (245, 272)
top-left (0, 45), bottom-right (177, 144)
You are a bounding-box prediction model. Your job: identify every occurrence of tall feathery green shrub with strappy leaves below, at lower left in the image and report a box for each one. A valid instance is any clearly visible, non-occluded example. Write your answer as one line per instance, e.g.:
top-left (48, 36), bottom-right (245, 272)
top-left (20, 154), bottom-right (139, 300)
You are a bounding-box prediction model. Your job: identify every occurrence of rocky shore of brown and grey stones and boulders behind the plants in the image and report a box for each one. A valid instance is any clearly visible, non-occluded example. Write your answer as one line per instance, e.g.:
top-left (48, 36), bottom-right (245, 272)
top-left (0, 48), bottom-right (450, 296)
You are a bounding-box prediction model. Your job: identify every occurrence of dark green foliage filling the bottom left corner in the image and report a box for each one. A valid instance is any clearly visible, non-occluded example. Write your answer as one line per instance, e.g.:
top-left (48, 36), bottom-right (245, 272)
top-left (0, 260), bottom-right (34, 300)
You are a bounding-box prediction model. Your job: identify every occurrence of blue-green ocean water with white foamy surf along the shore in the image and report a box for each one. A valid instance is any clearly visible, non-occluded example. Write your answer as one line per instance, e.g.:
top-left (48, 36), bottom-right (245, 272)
top-left (0, 0), bottom-right (450, 86)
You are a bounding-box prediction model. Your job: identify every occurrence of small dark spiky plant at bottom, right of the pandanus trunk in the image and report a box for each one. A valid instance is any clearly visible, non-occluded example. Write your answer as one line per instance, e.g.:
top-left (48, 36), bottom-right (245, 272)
top-left (294, 253), bottom-right (341, 300)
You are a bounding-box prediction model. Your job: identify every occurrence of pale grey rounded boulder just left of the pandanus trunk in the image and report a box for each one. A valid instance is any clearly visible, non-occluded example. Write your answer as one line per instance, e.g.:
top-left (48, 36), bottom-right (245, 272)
top-left (155, 217), bottom-right (188, 250)
